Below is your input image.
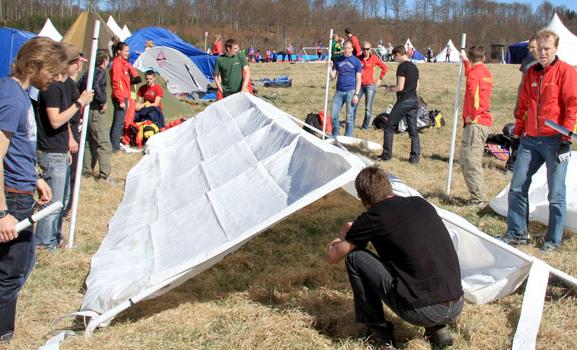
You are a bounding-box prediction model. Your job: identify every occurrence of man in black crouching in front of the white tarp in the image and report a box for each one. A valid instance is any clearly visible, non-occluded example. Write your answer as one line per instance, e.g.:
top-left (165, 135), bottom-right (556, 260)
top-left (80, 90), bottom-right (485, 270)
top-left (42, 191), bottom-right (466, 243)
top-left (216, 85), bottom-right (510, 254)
top-left (327, 166), bottom-right (464, 347)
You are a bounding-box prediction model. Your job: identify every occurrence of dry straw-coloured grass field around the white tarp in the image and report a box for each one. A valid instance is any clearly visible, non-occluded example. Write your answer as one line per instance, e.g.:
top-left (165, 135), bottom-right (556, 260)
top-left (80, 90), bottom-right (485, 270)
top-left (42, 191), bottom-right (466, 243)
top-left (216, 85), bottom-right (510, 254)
top-left (0, 63), bottom-right (577, 350)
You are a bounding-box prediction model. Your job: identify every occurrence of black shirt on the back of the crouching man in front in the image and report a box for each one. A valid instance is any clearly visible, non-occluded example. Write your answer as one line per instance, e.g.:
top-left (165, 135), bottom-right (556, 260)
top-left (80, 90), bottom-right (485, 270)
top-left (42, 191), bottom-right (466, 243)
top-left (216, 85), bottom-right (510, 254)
top-left (345, 196), bottom-right (463, 307)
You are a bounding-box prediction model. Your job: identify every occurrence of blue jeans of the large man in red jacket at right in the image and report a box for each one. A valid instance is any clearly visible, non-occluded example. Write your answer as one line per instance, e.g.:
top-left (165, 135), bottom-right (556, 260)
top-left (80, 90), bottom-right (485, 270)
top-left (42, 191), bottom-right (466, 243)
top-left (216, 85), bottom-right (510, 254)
top-left (507, 135), bottom-right (569, 247)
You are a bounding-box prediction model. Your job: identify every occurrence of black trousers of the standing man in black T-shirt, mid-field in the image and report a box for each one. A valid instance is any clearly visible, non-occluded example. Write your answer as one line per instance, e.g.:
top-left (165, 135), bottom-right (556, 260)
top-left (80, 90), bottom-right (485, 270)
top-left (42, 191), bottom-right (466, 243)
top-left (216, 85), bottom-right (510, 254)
top-left (383, 96), bottom-right (421, 159)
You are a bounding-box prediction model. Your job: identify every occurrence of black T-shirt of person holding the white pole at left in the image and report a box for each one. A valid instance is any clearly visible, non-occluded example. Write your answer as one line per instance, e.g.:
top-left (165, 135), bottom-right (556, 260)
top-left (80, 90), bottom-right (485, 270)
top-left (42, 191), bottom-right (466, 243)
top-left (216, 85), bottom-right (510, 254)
top-left (36, 81), bottom-right (74, 153)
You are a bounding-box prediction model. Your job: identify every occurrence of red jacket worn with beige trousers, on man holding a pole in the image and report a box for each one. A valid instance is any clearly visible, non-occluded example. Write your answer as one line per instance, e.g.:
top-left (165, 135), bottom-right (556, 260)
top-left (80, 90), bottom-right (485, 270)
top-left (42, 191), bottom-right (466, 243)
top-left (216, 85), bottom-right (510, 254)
top-left (463, 60), bottom-right (493, 127)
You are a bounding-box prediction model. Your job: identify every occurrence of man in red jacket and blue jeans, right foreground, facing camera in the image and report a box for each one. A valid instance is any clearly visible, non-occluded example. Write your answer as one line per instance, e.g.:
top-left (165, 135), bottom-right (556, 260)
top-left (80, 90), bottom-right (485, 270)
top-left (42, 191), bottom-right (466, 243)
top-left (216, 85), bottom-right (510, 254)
top-left (504, 29), bottom-right (577, 252)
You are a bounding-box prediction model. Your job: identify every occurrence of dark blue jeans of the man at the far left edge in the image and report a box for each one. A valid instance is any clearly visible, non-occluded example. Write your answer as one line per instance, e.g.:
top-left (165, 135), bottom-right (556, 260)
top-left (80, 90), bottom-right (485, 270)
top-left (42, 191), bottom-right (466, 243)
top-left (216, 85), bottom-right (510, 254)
top-left (0, 192), bottom-right (36, 337)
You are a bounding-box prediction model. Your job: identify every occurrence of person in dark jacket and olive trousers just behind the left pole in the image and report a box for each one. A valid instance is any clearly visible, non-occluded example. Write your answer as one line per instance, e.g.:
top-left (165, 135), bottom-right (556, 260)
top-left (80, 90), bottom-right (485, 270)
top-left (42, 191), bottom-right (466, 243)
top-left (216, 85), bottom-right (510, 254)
top-left (79, 50), bottom-right (113, 183)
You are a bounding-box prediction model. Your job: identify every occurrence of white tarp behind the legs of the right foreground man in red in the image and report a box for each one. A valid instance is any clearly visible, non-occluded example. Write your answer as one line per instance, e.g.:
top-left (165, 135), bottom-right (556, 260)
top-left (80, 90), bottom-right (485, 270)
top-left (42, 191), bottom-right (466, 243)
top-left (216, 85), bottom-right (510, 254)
top-left (489, 151), bottom-right (577, 232)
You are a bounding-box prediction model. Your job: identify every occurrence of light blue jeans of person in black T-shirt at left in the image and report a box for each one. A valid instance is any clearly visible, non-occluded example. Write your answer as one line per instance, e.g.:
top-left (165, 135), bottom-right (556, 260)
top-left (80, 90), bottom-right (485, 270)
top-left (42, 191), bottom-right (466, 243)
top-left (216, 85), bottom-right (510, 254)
top-left (36, 151), bottom-right (70, 250)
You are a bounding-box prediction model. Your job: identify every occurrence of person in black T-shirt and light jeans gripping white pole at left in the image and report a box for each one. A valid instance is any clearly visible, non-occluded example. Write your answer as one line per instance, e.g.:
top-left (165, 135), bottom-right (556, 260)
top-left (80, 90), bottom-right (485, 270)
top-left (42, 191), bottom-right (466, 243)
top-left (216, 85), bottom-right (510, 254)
top-left (36, 44), bottom-right (94, 250)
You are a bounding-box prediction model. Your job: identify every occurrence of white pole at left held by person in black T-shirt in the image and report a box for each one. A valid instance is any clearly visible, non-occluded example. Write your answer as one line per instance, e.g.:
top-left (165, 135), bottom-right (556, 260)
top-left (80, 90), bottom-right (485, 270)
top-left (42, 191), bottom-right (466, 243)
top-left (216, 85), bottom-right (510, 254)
top-left (68, 21), bottom-right (100, 248)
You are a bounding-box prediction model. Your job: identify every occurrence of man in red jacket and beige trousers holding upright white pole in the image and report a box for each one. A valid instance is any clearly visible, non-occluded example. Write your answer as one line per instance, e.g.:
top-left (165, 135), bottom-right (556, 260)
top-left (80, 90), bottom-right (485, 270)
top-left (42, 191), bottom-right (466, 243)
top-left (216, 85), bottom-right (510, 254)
top-left (460, 46), bottom-right (493, 204)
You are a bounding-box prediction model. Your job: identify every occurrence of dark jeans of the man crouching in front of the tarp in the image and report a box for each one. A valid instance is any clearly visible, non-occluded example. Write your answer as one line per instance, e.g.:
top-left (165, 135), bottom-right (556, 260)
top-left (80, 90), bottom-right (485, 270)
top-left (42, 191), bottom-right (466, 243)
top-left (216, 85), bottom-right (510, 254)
top-left (345, 249), bottom-right (464, 327)
